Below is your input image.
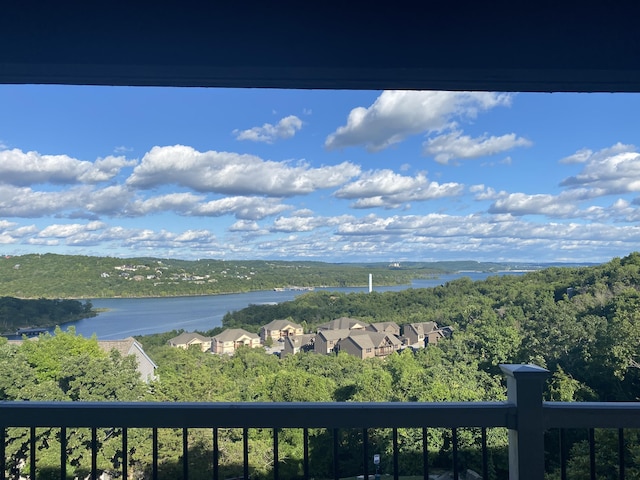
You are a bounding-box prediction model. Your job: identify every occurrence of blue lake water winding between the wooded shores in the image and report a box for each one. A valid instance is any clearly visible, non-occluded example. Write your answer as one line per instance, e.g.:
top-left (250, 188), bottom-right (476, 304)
top-left (11, 272), bottom-right (520, 340)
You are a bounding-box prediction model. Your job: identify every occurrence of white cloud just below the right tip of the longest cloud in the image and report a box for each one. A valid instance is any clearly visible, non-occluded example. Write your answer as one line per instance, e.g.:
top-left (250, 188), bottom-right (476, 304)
top-left (334, 169), bottom-right (464, 208)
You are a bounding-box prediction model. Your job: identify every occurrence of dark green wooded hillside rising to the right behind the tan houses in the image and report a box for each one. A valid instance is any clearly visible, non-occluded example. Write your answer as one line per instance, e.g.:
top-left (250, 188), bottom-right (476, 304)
top-left (223, 253), bottom-right (640, 400)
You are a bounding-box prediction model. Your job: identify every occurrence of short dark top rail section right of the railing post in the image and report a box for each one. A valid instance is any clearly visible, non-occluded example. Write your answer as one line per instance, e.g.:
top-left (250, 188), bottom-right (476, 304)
top-left (542, 402), bottom-right (640, 428)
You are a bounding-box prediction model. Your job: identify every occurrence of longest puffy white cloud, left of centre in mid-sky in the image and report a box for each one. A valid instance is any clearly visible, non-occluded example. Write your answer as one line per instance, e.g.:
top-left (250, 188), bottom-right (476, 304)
top-left (127, 145), bottom-right (360, 197)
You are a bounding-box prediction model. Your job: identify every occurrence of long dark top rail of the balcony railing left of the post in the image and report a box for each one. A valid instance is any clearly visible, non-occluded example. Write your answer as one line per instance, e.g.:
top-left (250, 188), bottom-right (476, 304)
top-left (0, 402), bottom-right (515, 428)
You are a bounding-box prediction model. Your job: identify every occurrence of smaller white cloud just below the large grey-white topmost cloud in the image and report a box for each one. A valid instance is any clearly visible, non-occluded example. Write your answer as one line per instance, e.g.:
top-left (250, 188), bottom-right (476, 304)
top-left (423, 130), bottom-right (533, 164)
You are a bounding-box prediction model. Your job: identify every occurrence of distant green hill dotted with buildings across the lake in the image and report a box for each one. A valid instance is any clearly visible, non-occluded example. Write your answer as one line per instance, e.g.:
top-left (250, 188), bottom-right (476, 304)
top-left (0, 254), bottom-right (523, 298)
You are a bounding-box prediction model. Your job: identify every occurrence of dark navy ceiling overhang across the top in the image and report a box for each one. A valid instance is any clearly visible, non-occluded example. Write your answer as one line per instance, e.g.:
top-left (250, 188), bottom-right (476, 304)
top-left (0, 0), bottom-right (640, 92)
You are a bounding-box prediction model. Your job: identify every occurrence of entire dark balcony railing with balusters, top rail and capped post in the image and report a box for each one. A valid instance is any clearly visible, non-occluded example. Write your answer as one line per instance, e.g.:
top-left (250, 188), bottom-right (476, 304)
top-left (0, 365), bottom-right (640, 480)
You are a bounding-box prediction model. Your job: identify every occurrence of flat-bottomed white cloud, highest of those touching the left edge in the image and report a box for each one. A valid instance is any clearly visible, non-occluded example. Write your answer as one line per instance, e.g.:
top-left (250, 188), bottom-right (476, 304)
top-left (0, 148), bottom-right (136, 186)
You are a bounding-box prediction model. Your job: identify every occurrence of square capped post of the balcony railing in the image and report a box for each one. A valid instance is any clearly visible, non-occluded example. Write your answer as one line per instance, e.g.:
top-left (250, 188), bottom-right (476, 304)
top-left (500, 365), bottom-right (549, 480)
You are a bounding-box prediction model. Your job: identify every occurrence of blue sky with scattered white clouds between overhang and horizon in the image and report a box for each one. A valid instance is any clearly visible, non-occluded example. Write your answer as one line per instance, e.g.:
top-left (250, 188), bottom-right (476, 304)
top-left (0, 85), bottom-right (640, 262)
